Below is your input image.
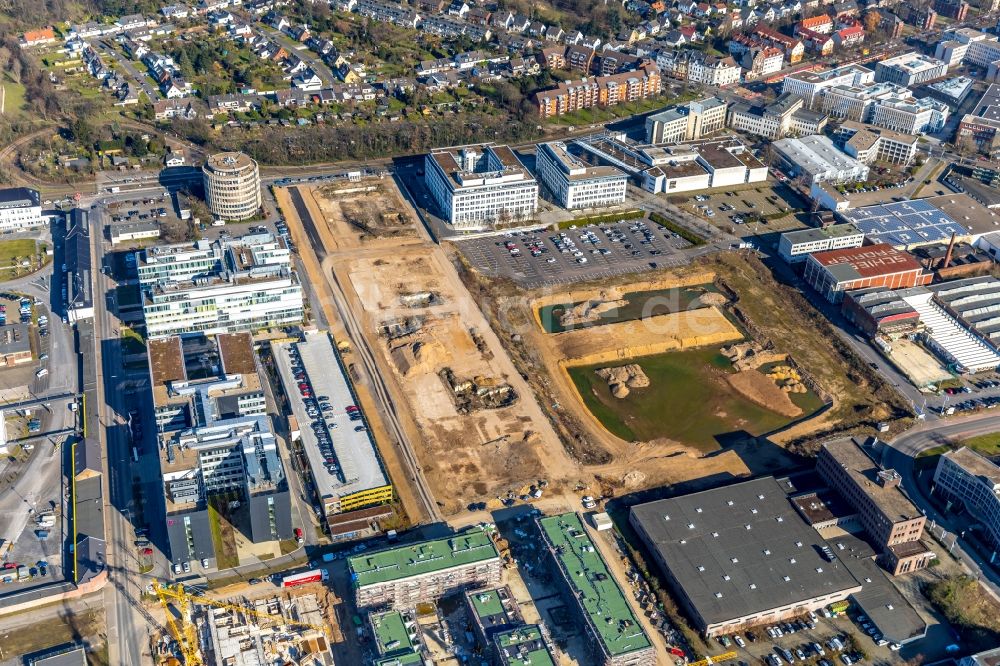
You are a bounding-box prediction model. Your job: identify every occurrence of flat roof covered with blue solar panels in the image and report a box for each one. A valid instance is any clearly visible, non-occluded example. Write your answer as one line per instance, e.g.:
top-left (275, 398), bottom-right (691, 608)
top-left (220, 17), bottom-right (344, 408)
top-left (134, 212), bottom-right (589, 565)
top-left (840, 199), bottom-right (969, 247)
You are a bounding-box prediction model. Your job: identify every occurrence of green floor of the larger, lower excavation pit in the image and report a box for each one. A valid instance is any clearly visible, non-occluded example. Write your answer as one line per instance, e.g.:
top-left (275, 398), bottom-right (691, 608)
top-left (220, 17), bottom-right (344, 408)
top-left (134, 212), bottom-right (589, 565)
top-left (569, 347), bottom-right (821, 451)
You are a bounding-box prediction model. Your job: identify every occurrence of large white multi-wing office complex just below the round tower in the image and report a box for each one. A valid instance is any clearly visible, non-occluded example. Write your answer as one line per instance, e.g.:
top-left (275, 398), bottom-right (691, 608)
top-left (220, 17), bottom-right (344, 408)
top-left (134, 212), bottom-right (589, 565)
top-left (138, 233), bottom-right (304, 338)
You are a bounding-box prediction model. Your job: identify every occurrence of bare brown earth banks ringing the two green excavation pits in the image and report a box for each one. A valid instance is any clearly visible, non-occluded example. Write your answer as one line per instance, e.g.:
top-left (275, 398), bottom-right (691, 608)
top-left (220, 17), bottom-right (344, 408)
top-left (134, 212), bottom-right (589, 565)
top-left (462, 246), bottom-right (908, 488)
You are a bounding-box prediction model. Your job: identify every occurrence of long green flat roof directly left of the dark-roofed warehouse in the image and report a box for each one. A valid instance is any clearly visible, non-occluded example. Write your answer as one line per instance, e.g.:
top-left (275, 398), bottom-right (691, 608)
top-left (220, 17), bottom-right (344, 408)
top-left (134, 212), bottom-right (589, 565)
top-left (538, 513), bottom-right (652, 656)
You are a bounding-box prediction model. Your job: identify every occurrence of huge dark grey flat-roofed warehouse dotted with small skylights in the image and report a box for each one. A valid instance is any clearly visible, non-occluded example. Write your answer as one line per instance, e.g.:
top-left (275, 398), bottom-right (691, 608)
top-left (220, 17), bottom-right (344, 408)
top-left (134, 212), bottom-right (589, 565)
top-left (631, 477), bottom-right (861, 629)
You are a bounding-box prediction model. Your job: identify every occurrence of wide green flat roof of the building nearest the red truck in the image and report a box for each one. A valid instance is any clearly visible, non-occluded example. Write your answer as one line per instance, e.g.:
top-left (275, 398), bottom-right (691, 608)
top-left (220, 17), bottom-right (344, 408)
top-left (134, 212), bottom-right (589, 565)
top-left (347, 528), bottom-right (500, 588)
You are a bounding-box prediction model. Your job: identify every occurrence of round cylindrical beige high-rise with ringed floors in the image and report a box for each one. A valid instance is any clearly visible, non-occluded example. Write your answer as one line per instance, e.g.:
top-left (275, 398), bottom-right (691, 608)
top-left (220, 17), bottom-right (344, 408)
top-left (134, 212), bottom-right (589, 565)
top-left (201, 153), bottom-right (261, 220)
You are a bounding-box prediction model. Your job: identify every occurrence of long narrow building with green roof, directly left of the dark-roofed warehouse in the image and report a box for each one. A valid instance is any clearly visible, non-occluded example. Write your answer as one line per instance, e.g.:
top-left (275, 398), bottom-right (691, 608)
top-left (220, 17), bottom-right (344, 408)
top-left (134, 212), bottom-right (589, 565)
top-left (537, 513), bottom-right (656, 666)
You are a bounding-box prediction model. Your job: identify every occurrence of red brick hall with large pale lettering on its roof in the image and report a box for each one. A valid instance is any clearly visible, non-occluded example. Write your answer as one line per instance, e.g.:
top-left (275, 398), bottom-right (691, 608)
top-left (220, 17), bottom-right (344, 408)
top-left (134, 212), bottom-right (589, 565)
top-left (804, 243), bottom-right (932, 303)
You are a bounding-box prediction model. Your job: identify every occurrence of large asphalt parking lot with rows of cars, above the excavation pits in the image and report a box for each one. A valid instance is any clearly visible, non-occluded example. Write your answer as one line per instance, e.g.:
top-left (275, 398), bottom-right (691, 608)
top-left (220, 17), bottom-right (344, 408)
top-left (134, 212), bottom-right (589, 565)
top-left (456, 220), bottom-right (691, 289)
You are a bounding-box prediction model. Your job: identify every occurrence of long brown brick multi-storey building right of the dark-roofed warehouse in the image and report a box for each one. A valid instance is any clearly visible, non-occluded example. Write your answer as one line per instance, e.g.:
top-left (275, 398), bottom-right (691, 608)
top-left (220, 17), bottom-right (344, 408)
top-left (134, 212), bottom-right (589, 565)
top-left (816, 436), bottom-right (935, 575)
